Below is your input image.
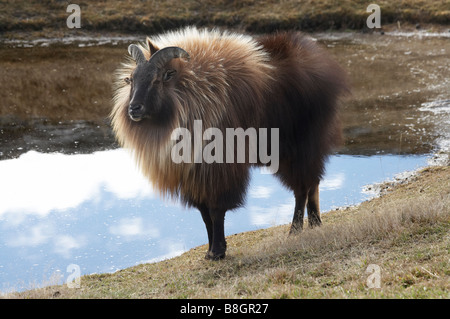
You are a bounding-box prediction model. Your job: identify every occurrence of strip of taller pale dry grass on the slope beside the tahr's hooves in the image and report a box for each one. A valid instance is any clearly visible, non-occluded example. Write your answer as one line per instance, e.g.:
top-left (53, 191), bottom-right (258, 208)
top-left (241, 195), bottom-right (450, 274)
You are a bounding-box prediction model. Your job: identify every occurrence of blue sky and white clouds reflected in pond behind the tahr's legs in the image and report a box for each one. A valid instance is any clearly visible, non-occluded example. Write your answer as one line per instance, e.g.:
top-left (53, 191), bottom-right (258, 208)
top-left (0, 149), bottom-right (428, 291)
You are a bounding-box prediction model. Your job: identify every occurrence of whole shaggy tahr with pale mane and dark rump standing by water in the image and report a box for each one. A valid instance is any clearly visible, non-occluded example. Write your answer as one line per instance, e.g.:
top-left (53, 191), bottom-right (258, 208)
top-left (111, 27), bottom-right (348, 259)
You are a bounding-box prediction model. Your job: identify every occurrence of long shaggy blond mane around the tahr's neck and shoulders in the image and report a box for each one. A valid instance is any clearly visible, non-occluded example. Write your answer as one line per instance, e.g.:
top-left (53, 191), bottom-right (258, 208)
top-left (111, 27), bottom-right (273, 208)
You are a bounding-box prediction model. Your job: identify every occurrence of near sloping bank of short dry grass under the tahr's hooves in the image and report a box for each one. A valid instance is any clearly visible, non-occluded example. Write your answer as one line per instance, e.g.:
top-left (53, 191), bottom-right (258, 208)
top-left (12, 167), bottom-right (450, 298)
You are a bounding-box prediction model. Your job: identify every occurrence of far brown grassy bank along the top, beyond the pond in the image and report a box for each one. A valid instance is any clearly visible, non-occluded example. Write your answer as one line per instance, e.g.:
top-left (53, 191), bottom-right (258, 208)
top-left (0, 0), bottom-right (450, 35)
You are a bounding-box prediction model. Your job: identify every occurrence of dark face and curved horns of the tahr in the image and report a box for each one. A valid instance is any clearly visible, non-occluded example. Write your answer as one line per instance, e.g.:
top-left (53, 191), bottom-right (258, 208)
top-left (125, 41), bottom-right (189, 122)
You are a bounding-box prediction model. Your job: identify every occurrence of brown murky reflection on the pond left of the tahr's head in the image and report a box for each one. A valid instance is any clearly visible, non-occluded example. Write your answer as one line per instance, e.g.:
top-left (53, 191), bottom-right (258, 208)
top-left (0, 46), bottom-right (121, 121)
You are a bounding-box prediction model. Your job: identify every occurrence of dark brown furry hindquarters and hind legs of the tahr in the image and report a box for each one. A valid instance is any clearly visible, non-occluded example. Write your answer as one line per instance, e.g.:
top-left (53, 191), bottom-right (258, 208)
top-left (259, 33), bottom-right (348, 232)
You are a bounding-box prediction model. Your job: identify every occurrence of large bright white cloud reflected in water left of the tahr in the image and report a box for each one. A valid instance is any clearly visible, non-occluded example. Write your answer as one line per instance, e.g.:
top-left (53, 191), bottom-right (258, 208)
top-left (0, 149), bottom-right (153, 216)
